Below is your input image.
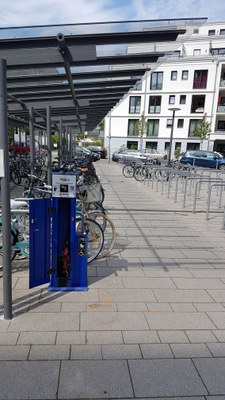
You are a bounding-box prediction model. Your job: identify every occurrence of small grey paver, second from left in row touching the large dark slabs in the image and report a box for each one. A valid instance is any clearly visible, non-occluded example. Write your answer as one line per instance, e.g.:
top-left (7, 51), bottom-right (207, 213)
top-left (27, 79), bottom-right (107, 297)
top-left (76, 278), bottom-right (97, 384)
top-left (29, 345), bottom-right (70, 360)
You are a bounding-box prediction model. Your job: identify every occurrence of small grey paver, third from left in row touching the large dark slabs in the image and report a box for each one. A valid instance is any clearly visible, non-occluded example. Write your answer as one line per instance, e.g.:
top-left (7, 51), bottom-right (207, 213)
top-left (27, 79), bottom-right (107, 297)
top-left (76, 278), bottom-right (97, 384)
top-left (70, 344), bottom-right (102, 360)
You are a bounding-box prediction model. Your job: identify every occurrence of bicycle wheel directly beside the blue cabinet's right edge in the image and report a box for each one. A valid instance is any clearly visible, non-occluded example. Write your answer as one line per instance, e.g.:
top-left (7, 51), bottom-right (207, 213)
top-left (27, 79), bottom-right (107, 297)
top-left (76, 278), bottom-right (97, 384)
top-left (76, 218), bottom-right (104, 263)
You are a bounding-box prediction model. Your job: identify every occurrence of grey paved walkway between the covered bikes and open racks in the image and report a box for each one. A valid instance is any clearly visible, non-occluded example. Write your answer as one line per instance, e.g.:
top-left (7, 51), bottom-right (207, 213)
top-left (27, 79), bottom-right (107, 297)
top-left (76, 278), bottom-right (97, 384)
top-left (0, 160), bottom-right (225, 400)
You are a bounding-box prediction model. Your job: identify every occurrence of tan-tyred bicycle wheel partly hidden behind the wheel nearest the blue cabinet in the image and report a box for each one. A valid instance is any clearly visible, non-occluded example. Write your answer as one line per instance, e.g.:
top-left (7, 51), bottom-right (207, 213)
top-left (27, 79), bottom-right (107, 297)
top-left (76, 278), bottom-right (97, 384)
top-left (88, 211), bottom-right (116, 259)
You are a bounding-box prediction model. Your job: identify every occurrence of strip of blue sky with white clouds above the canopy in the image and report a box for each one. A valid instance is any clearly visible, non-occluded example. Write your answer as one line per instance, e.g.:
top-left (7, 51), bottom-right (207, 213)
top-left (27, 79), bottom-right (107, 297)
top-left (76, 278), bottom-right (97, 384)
top-left (0, 0), bottom-right (225, 27)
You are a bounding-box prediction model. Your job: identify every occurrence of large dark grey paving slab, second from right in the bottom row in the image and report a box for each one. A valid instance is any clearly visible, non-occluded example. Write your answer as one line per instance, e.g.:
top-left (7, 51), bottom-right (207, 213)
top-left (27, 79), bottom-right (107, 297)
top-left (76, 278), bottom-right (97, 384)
top-left (129, 359), bottom-right (208, 398)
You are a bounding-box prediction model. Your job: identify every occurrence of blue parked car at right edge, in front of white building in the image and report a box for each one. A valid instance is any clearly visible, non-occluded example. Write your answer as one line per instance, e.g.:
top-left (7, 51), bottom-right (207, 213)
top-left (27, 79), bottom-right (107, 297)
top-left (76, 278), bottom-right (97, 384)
top-left (179, 150), bottom-right (225, 169)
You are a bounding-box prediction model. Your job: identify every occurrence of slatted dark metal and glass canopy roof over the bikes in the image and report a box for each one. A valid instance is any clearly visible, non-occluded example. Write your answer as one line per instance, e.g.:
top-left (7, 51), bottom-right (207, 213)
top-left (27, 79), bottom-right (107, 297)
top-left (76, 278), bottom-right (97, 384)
top-left (0, 18), bottom-right (206, 131)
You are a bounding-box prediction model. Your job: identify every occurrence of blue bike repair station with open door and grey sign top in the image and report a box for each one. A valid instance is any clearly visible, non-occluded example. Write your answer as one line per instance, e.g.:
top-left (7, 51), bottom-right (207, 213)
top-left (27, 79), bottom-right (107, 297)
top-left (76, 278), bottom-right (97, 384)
top-left (29, 173), bottom-right (88, 291)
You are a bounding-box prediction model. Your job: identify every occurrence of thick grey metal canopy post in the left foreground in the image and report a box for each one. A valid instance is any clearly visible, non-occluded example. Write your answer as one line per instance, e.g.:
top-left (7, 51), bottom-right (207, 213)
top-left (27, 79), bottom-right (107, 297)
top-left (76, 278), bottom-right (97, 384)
top-left (0, 59), bottom-right (12, 319)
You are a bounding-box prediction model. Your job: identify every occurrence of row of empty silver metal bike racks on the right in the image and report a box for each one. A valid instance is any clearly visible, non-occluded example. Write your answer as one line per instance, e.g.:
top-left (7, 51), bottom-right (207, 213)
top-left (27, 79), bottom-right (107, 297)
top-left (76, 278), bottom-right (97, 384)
top-left (137, 165), bottom-right (225, 225)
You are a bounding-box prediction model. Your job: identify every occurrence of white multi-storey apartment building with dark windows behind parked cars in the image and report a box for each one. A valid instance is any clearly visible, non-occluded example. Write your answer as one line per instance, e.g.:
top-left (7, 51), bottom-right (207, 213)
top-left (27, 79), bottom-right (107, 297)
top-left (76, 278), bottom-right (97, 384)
top-left (104, 21), bottom-right (225, 157)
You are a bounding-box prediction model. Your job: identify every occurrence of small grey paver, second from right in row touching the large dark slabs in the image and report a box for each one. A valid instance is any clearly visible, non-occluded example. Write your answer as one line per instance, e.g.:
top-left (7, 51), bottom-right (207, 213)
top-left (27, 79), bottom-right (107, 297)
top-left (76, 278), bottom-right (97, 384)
top-left (170, 343), bottom-right (212, 358)
